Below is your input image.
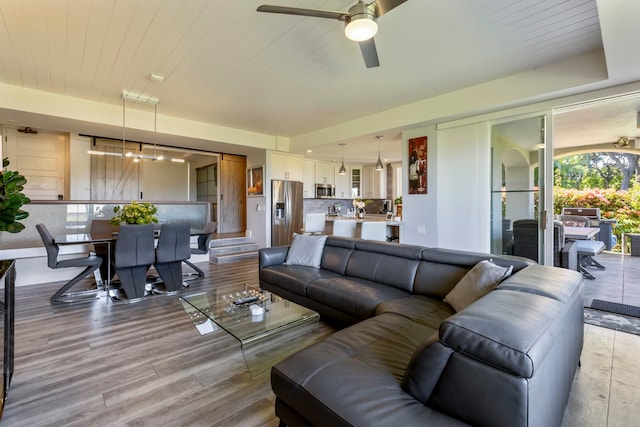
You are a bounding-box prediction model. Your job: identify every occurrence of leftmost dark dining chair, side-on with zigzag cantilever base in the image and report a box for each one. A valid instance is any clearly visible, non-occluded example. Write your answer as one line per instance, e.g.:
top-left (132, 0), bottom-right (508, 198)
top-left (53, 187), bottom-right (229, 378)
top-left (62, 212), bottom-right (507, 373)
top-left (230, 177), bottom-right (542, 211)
top-left (36, 224), bottom-right (102, 304)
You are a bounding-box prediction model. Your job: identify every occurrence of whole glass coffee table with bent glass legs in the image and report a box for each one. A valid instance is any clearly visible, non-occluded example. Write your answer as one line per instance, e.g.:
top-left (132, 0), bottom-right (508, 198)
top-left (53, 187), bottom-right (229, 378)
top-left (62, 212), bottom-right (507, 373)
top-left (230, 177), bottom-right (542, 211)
top-left (180, 284), bottom-right (320, 377)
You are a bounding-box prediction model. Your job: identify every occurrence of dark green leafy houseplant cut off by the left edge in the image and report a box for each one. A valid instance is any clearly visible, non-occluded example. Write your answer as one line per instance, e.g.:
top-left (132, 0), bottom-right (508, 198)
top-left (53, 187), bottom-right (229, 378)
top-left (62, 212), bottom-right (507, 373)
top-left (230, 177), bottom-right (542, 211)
top-left (0, 157), bottom-right (31, 233)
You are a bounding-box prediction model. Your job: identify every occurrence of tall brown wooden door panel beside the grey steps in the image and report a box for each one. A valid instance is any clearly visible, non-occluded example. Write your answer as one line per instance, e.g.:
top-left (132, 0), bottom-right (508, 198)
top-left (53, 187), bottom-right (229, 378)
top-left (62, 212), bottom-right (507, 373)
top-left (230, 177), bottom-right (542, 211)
top-left (218, 154), bottom-right (247, 233)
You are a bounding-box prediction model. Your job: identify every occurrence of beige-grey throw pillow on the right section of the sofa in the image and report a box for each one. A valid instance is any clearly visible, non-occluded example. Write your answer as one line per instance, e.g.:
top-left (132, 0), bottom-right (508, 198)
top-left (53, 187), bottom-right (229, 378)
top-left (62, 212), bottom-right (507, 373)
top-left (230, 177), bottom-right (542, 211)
top-left (444, 260), bottom-right (513, 311)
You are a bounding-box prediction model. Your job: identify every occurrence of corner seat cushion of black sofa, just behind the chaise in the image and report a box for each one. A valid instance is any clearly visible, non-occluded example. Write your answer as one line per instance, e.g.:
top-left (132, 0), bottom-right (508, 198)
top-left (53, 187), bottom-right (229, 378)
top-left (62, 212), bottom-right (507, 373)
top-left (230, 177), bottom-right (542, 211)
top-left (375, 295), bottom-right (455, 329)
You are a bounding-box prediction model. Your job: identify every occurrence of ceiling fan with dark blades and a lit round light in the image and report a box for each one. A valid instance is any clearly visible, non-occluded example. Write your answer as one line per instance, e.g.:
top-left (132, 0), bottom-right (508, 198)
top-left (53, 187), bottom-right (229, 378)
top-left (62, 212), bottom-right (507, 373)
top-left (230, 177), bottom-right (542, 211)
top-left (257, 0), bottom-right (407, 68)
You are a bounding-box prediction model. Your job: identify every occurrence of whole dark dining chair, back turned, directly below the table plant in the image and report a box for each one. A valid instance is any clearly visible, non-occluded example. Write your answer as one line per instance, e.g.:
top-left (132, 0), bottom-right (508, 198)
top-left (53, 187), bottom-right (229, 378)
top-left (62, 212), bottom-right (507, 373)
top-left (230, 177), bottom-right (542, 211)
top-left (115, 224), bottom-right (155, 300)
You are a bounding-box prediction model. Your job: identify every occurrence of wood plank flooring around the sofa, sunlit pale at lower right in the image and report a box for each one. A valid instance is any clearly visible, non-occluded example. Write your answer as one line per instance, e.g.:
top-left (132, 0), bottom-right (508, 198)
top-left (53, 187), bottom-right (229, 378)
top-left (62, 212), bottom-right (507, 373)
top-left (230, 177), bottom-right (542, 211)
top-left (0, 259), bottom-right (640, 427)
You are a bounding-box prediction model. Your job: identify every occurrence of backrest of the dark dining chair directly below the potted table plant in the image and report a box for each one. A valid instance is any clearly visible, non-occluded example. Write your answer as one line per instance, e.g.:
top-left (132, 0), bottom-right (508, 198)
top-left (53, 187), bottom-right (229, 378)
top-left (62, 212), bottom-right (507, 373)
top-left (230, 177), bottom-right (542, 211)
top-left (115, 224), bottom-right (155, 268)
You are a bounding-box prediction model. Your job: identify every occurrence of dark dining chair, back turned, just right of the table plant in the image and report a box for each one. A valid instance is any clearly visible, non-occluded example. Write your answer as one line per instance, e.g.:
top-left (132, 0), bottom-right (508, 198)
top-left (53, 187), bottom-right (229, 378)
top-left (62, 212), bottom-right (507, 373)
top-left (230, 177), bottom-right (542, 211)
top-left (153, 224), bottom-right (191, 292)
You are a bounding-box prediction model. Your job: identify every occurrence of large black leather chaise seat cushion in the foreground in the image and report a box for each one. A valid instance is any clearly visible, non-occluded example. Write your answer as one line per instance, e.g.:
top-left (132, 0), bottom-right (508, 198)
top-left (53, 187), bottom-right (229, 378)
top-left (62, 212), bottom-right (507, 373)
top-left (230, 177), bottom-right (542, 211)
top-left (271, 314), bottom-right (464, 426)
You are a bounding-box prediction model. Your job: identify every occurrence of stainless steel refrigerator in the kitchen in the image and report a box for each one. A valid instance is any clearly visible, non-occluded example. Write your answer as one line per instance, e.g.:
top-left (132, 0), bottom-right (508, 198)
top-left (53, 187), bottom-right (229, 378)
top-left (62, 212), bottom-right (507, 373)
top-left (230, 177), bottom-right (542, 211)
top-left (271, 180), bottom-right (303, 246)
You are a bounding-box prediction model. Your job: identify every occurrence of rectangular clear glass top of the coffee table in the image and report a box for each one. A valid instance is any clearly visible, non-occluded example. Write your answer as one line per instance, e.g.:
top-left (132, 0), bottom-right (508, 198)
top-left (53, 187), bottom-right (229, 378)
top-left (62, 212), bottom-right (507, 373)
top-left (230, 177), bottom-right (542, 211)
top-left (181, 284), bottom-right (319, 346)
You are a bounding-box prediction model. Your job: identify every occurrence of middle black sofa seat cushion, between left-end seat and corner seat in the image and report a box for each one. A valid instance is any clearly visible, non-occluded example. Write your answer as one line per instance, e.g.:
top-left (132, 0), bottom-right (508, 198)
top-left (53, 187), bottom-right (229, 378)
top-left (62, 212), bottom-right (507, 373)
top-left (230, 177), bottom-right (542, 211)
top-left (307, 277), bottom-right (409, 319)
